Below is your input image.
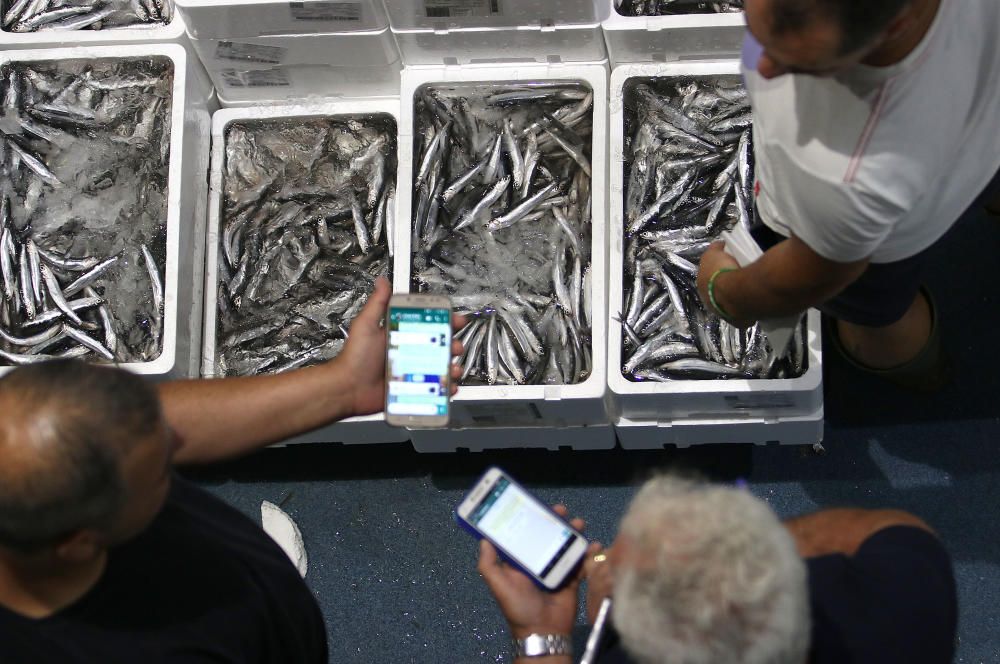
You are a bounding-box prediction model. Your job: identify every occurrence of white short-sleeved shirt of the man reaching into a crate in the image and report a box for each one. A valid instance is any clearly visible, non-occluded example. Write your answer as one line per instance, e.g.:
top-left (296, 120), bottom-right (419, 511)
top-left (743, 0), bottom-right (1000, 263)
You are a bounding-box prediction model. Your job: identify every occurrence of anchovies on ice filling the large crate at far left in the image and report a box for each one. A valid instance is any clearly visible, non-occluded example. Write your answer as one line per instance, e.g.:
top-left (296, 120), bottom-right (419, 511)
top-left (0, 58), bottom-right (173, 365)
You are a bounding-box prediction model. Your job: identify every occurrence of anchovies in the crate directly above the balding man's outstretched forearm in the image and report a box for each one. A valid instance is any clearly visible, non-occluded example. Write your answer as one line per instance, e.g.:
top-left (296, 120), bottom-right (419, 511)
top-left (216, 115), bottom-right (396, 376)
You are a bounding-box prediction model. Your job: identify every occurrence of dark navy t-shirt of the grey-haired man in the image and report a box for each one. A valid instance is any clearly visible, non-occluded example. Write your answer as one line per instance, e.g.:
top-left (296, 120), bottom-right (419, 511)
top-left (598, 526), bottom-right (958, 664)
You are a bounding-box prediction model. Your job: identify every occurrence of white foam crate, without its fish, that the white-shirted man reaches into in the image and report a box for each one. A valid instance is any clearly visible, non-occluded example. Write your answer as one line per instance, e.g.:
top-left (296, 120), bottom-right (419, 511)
top-left (608, 60), bottom-right (823, 421)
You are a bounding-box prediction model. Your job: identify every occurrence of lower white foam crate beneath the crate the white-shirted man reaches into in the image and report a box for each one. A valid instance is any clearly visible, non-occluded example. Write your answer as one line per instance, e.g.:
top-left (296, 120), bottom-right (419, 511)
top-left (615, 406), bottom-right (824, 450)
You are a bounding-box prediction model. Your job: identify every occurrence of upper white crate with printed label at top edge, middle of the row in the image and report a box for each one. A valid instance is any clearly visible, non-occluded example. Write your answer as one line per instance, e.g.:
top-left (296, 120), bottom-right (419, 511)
top-left (385, 0), bottom-right (605, 32)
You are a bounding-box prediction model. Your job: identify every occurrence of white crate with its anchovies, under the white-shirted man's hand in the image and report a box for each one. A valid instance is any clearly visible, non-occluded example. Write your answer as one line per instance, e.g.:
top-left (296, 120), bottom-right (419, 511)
top-left (608, 61), bottom-right (823, 421)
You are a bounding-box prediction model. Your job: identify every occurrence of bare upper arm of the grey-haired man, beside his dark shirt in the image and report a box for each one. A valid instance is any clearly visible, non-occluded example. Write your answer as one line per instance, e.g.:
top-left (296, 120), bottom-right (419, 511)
top-left (785, 509), bottom-right (934, 558)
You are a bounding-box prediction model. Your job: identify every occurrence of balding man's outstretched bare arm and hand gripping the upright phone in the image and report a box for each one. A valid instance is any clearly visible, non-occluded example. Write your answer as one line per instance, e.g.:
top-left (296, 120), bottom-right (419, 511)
top-left (159, 279), bottom-right (461, 464)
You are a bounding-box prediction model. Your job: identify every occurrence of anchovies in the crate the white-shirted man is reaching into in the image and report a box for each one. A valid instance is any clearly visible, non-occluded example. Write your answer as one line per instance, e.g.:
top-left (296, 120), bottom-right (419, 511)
top-left (619, 77), bottom-right (805, 381)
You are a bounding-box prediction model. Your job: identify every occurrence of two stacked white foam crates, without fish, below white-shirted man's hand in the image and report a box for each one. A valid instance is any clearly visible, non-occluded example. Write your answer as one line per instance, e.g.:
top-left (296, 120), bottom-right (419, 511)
top-left (608, 59), bottom-right (823, 449)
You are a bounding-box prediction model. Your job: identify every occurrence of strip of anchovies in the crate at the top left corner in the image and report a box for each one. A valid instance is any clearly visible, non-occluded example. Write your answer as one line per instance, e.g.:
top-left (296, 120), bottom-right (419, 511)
top-left (0, 0), bottom-right (173, 32)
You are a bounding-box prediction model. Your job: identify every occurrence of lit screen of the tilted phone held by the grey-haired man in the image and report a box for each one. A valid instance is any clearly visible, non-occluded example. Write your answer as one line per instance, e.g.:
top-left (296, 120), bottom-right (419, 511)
top-left (469, 477), bottom-right (573, 577)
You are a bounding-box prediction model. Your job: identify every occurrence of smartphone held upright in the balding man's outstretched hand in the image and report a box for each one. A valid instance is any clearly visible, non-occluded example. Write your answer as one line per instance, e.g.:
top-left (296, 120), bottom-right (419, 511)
top-left (385, 293), bottom-right (451, 429)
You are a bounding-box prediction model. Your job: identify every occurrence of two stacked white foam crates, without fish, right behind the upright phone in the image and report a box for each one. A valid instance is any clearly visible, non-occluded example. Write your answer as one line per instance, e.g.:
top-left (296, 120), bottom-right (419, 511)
top-left (394, 62), bottom-right (615, 452)
